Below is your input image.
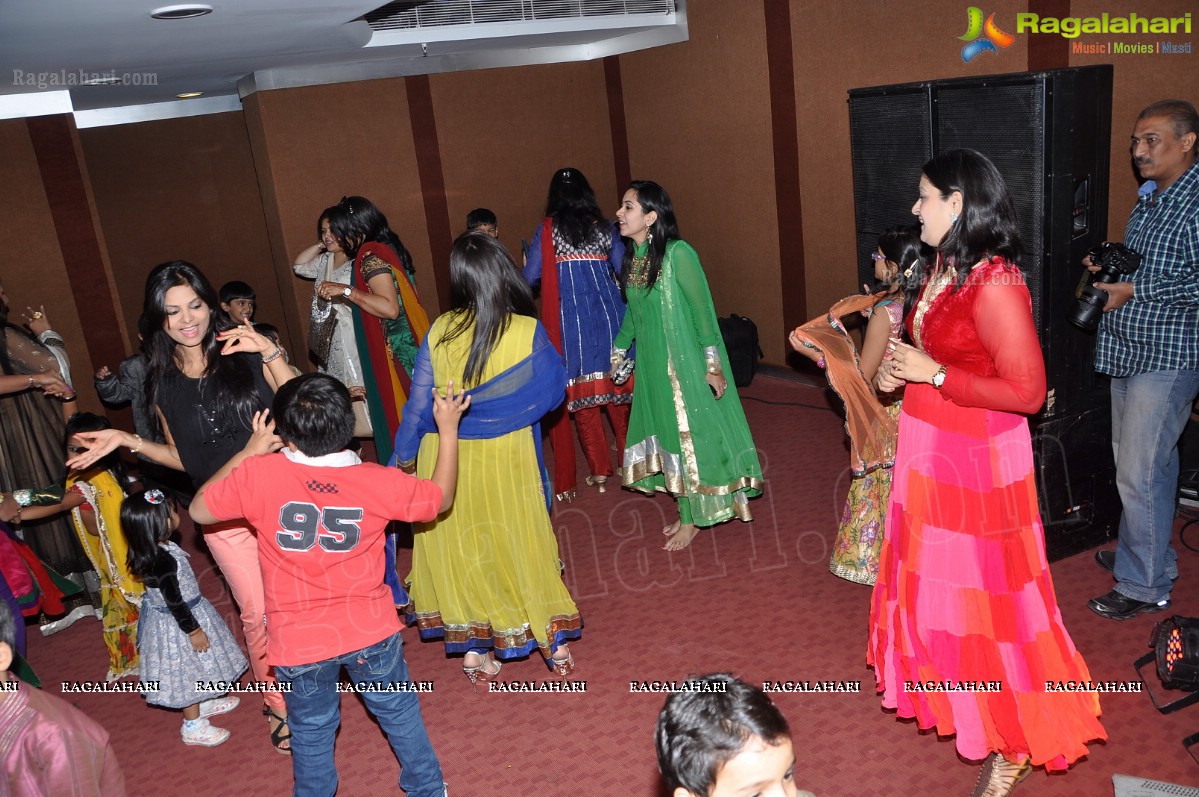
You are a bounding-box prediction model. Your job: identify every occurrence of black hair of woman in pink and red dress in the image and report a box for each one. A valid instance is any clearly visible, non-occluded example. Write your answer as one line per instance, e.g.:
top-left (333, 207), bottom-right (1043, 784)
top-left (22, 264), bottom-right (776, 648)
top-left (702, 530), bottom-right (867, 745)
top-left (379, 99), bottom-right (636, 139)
top-left (923, 150), bottom-right (1023, 290)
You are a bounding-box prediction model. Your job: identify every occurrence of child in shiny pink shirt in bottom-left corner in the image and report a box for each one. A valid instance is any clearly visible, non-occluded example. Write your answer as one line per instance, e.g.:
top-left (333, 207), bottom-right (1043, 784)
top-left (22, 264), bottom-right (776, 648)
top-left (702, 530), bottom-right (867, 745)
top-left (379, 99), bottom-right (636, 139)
top-left (0, 600), bottom-right (128, 797)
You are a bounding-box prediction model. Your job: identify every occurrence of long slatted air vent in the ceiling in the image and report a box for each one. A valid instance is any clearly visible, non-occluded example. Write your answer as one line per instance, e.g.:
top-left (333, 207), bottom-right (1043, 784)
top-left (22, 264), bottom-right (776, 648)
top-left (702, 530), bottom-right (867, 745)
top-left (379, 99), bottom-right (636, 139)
top-left (366, 0), bottom-right (675, 30)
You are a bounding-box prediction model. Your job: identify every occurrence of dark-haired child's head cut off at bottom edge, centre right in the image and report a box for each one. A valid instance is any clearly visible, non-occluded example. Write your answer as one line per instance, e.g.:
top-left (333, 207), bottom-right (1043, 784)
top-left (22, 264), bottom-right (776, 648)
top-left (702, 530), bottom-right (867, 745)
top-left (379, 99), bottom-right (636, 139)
top-left (653, 675), bottom-right (813, 797)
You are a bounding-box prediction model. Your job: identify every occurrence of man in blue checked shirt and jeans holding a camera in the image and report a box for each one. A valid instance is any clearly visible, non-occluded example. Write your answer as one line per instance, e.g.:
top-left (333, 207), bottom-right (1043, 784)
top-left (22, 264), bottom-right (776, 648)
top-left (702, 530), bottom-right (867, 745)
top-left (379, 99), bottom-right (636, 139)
top-left (1087, 99), bottom-right (1199, 620)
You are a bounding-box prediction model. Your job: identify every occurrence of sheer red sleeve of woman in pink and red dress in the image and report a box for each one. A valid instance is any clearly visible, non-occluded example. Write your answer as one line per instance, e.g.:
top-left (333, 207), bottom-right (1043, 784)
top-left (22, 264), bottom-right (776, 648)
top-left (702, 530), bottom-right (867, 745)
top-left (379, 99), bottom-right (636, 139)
top-left (941, 271), bottom-right (1046, 415)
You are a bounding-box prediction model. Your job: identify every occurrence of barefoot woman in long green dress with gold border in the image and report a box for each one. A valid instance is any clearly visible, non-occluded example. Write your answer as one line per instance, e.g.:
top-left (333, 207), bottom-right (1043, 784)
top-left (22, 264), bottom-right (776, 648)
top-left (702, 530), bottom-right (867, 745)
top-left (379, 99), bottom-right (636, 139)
top-left (613, 181), bottom-right (763, 550)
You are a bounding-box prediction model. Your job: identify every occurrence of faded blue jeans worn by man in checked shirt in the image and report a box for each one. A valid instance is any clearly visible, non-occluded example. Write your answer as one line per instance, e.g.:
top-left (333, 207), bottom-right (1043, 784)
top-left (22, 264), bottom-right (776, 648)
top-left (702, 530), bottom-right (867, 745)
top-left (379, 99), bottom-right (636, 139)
top-left (1111, 370), bottom-right (1199, 602)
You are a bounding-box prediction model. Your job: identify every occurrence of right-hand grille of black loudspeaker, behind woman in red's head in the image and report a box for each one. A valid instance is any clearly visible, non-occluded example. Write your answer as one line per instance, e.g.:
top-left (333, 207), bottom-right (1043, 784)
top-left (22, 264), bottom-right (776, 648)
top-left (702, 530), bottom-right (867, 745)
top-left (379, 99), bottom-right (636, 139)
top-left (934, 83), bottom-right (1047, 328)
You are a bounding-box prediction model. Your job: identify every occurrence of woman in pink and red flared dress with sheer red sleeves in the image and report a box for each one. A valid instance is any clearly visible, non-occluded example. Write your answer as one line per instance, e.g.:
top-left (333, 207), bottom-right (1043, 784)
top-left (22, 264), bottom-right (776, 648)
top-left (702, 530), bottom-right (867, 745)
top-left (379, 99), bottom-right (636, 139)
top-left (867, 150), bottom-right (1107, 797)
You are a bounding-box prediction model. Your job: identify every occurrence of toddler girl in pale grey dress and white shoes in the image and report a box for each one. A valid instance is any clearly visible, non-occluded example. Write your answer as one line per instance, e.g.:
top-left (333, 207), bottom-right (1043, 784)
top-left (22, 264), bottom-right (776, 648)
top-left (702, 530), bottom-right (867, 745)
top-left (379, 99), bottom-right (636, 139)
top-left (121, 490), bottom-right (249, 747)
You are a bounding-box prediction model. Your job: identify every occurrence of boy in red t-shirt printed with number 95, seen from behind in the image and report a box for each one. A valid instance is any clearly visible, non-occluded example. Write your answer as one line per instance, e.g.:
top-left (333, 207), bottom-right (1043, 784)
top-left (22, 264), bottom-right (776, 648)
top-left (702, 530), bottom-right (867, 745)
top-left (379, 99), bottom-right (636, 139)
top-left (188, 374), bottom-right (470, 797)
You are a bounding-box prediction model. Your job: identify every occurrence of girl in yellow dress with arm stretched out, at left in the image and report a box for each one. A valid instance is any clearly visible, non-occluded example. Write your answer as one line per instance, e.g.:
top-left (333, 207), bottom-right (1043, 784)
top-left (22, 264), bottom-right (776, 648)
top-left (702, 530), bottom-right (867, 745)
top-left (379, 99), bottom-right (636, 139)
top-left (2, 412), bottom-right (143, 681)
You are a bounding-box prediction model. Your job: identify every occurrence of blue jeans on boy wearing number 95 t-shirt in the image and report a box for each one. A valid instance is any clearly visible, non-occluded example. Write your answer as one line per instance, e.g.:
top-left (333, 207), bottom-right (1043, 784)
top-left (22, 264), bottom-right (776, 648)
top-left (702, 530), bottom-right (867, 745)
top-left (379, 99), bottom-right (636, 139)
top-left (275, 632), bottom-right (445, 797)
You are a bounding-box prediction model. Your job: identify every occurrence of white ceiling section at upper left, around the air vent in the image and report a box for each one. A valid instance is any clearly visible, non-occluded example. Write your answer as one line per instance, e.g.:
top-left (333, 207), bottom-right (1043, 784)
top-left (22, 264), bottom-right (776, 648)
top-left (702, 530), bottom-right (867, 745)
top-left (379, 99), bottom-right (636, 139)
top-left (0, 0), bottom-right (687, 123)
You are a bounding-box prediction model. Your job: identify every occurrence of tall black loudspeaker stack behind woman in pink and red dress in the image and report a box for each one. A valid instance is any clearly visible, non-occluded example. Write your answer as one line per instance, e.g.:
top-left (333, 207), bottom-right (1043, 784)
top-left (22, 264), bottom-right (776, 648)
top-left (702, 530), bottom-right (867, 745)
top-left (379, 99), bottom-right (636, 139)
top-left (849, 65), bottom-right (1120, 558)
